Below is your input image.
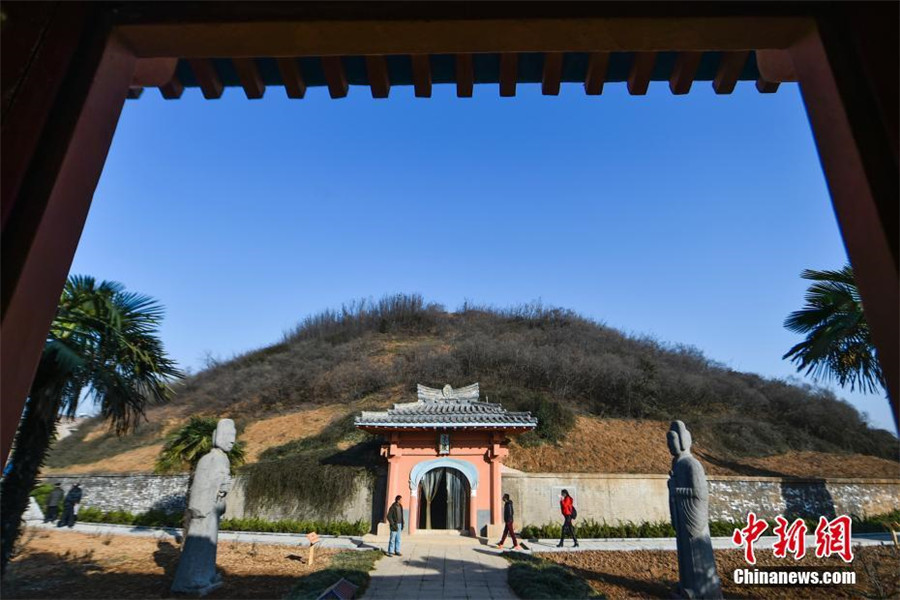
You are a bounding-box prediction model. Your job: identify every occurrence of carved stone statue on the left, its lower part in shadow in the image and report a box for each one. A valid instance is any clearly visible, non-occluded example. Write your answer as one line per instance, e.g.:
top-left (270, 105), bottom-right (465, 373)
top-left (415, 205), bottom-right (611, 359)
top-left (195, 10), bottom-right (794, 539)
top-left (172, 419), bottom-right (236, 596)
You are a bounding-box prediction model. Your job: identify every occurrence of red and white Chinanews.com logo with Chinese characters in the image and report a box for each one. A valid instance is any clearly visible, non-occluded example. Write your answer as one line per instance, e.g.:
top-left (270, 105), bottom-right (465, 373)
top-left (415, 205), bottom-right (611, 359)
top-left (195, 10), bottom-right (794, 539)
top-left (731, 512), bottom-right (856, 585)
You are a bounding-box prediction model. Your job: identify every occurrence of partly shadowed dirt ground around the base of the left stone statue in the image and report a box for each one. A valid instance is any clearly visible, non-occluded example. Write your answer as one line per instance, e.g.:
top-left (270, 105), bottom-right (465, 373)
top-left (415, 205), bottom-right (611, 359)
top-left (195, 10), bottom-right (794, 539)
top-left (2, 529), bottom-right (335, 599)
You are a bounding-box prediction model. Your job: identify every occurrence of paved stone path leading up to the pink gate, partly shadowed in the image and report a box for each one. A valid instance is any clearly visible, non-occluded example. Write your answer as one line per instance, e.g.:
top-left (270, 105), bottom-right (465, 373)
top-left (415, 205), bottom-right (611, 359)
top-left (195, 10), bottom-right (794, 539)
top-left (364, 536), bottom-right (516, 600)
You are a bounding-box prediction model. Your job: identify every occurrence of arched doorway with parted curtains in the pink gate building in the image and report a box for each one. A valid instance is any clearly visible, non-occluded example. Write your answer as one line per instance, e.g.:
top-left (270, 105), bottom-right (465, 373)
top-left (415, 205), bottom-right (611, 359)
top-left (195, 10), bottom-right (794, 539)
top-left (417, 467), bottom-right (471, 530)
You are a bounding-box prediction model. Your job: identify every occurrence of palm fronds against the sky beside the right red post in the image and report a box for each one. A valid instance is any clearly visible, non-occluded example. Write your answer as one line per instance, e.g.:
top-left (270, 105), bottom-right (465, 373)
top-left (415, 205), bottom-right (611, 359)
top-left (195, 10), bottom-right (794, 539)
top-left (782, 264), bottom-right (885, 393)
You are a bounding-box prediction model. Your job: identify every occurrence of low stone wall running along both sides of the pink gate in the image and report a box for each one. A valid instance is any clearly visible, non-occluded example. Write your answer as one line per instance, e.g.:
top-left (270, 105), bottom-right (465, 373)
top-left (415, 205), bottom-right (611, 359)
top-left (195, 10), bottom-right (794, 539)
top-left (43, 472), bottom-right (900, 525)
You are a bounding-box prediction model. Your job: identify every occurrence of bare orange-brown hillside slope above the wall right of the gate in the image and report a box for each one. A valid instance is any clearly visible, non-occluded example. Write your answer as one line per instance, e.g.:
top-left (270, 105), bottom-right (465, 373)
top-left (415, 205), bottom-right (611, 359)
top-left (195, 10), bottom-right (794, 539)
top-left (505, 416), bottom-right (900, 478)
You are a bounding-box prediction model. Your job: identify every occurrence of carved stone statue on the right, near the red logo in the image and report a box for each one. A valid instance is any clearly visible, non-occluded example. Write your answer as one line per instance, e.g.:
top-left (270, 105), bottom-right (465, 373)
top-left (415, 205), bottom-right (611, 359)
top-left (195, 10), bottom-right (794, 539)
top-left (666, 421), bottom-right (722, 598)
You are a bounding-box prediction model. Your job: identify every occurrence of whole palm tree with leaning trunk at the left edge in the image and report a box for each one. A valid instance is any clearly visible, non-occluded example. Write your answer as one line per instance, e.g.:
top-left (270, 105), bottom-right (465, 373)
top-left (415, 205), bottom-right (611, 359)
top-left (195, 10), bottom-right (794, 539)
top-left (0, 276), bottom-right (182, 571)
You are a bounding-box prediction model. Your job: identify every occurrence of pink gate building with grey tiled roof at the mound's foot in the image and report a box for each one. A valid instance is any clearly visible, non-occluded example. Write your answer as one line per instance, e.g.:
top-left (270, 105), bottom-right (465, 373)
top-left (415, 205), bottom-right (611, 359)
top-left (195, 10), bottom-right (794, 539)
top-left (356, 383), bottom-right (537, 535)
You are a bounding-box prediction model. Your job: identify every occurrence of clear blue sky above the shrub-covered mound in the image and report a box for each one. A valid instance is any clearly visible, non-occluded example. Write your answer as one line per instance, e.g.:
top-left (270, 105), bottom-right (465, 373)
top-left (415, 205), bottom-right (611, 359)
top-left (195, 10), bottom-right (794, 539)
top-left (72, 82), bottom-right (893, 430)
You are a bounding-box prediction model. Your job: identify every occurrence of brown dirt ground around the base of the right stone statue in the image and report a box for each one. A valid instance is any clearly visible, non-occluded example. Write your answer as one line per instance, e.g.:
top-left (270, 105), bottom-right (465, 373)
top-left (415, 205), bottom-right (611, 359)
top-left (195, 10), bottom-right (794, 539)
top-left (540, 546), bottom-right (900, 600)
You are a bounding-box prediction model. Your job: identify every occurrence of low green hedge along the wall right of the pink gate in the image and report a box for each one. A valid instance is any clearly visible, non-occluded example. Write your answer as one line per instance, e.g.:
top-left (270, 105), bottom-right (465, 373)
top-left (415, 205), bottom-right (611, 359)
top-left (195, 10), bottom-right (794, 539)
top-left (520, 510), bottom-right (900, 539)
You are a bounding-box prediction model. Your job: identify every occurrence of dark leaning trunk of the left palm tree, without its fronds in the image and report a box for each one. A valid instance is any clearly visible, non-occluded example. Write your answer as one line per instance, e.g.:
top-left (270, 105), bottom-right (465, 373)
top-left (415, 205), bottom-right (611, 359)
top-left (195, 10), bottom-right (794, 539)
top-left (0, 399), bottom-right (56, 573)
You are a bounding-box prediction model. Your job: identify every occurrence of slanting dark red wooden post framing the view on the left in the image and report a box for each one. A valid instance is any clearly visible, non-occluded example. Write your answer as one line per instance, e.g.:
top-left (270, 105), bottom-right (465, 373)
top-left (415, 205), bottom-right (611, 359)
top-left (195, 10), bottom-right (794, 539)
top-left (0, 32), bottom-right (136, 461)
